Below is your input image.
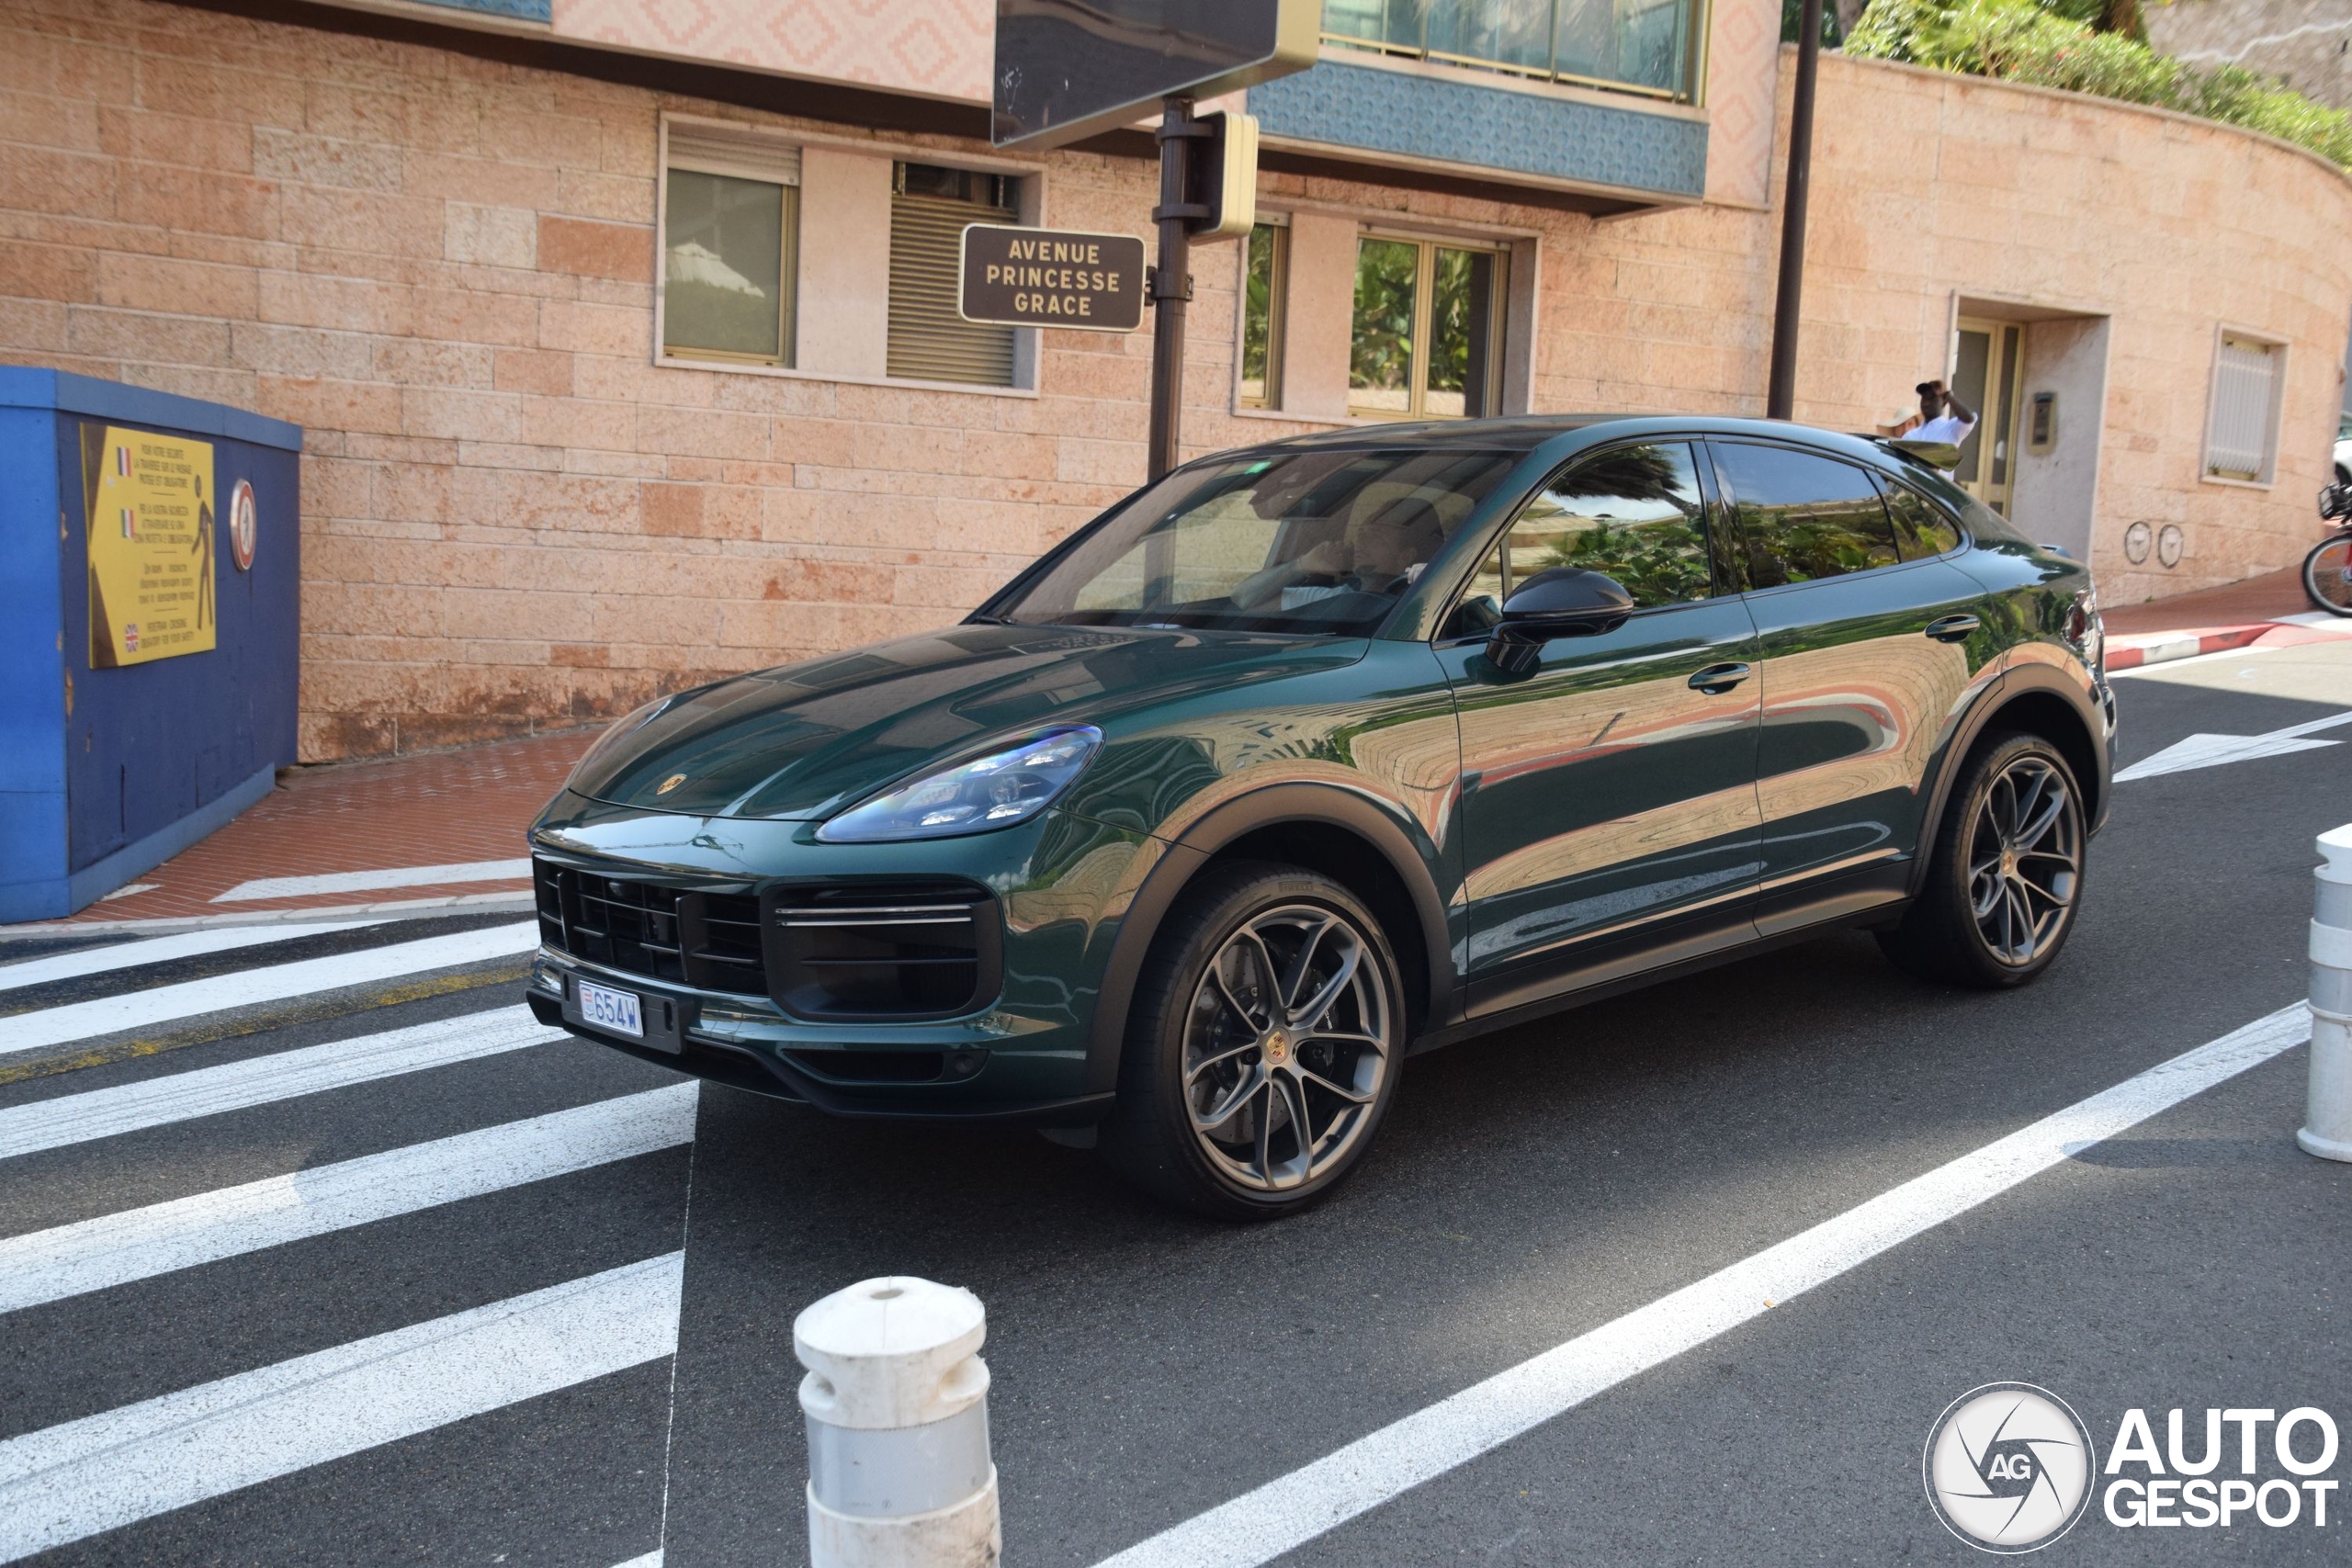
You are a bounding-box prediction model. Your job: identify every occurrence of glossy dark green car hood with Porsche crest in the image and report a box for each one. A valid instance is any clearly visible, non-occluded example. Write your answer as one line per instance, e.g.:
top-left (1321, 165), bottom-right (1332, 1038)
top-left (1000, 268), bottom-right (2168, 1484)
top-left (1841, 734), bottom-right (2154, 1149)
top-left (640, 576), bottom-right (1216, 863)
top-left (571, 626), bottom-right (1364, 820)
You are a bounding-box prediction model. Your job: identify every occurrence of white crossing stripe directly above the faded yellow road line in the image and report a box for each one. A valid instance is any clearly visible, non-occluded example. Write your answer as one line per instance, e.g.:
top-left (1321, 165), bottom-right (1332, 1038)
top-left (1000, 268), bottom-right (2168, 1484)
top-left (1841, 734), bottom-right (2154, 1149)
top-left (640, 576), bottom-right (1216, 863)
top-left (0, 919), bottom-right (538, 1055)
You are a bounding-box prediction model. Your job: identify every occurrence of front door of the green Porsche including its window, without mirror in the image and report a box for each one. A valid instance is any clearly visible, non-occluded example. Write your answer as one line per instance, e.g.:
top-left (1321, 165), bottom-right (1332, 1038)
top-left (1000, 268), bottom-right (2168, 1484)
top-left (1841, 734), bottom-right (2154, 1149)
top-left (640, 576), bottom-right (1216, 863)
top-left (1437, 442), bottom-right (1759, 1013)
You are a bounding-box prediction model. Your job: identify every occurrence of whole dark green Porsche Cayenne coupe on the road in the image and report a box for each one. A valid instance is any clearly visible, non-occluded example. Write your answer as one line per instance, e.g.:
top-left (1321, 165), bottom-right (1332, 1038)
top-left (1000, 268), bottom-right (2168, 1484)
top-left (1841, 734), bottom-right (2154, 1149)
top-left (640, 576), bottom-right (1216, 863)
top-left (529, 419), bottom-right (2114, 1215)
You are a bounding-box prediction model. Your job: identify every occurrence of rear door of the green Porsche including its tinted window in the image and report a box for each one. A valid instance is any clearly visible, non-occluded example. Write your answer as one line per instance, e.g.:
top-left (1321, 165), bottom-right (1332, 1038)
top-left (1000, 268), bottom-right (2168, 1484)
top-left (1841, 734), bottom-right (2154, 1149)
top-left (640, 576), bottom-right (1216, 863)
top-left (1710, 440), bottom-right (1996, 936)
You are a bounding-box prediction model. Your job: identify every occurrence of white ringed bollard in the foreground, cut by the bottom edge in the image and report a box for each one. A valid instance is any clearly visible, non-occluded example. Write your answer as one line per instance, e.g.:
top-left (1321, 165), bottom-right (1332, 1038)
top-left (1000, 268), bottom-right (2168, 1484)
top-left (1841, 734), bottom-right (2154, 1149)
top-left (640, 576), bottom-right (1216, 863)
top-left (793, 1274), bottom-right (1004, 1568)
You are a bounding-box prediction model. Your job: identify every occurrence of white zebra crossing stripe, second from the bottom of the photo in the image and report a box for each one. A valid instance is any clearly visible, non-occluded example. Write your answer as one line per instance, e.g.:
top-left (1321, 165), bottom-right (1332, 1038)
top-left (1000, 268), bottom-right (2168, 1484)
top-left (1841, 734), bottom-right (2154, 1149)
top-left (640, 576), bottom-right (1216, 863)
top-left (0, 1084), bottom-right (696, 1312)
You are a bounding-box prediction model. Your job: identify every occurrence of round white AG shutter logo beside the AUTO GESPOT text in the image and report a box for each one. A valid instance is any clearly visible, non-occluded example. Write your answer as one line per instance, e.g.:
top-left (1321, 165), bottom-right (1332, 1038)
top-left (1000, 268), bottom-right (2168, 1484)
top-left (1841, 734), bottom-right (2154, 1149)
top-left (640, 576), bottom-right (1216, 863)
top-left (1922, 1382), bottom-right (2098, 1554)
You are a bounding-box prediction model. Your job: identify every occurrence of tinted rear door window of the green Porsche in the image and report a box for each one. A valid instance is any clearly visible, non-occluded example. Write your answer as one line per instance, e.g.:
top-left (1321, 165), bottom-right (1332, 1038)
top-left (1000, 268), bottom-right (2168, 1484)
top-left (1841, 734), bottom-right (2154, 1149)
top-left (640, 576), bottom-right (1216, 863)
top-left (1714, 442), bottom-right (1898, 588)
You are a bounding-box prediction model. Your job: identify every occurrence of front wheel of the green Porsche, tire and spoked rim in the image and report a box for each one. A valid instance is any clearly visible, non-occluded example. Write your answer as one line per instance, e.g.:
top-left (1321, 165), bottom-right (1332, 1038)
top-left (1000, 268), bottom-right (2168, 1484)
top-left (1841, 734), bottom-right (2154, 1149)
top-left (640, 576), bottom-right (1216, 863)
top-left (1101, 863), bottom-right (1404, 1220)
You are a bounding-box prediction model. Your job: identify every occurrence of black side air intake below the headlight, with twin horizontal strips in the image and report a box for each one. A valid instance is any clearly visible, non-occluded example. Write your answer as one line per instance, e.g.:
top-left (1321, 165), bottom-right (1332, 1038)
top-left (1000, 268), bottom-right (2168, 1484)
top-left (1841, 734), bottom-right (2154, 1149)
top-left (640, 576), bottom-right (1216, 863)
top-left (774, 882), bottom-right (997, 1021)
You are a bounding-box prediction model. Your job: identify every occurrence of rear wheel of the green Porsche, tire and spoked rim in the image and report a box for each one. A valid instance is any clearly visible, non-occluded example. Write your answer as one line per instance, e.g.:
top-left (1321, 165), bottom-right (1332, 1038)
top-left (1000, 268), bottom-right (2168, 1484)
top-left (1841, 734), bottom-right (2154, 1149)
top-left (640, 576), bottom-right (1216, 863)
top-left (1877, 733), bottom-right (2086, 989)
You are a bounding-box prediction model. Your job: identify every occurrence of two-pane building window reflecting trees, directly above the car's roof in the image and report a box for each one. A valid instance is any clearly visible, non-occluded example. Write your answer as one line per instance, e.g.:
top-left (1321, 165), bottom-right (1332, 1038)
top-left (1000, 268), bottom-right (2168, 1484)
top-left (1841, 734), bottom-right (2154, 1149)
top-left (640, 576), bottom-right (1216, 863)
top-left (1348, 235), bottom-right (1505, 419)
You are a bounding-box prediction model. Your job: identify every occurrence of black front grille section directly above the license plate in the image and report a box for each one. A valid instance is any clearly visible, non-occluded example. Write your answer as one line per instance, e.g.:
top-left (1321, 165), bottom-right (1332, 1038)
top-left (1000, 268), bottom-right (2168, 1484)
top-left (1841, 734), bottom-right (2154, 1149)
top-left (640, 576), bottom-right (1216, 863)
top-left (532, 861), bottom-right (767, 997)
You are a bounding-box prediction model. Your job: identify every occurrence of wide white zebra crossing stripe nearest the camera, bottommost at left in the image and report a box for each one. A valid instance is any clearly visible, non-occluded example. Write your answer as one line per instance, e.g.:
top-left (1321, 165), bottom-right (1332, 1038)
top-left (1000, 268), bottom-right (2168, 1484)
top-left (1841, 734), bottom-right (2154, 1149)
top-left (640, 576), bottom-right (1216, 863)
top-left (0, 1253), bottom-right (684, 1561)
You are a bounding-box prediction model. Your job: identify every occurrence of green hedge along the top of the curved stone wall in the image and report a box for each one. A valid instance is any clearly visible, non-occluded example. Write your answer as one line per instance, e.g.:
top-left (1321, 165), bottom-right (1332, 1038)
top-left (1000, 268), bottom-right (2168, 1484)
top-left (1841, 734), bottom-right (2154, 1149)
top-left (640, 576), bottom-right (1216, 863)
top-left (1847, 0), bottom-right (2352, 169)
